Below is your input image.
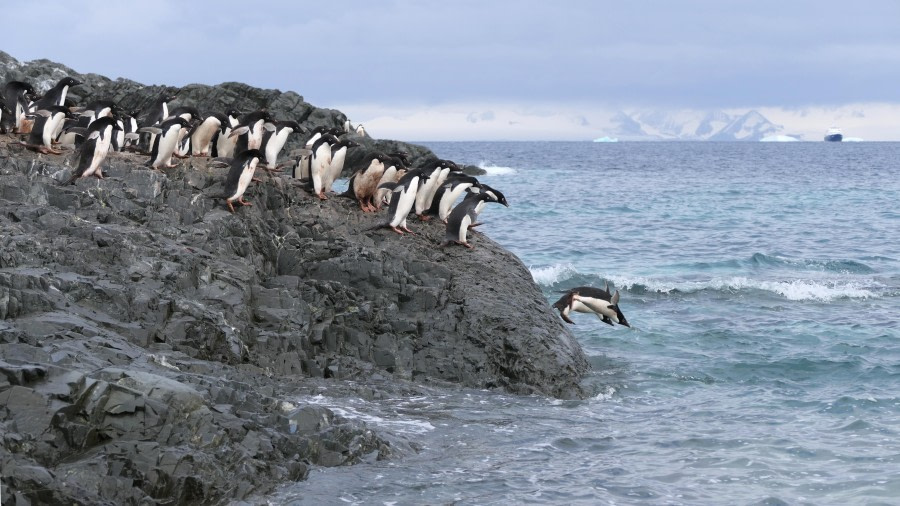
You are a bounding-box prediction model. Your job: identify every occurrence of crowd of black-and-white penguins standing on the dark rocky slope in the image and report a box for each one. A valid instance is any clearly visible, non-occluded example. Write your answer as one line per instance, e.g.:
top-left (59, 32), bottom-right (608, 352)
top-left (0, 77), bottom-right (509, 249)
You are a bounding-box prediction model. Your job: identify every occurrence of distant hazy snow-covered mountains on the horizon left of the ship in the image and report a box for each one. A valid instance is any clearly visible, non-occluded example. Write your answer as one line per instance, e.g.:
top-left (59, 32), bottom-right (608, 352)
top-left (609, 110), bottom-right (784, 141)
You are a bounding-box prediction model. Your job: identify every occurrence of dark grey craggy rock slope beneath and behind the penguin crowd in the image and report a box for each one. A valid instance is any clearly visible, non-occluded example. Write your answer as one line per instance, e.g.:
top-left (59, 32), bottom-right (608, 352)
top-left (0, 55), bottom-right (589, 504)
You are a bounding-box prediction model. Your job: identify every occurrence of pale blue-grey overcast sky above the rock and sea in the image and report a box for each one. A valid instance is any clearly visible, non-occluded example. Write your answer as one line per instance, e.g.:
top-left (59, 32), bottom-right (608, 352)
top-left (0, 0), bottom-right (900, 140)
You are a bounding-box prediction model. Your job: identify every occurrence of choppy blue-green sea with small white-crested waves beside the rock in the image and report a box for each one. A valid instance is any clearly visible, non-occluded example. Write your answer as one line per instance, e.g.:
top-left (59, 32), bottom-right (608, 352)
top-left (271, 142), bottom-right (900, 505)
